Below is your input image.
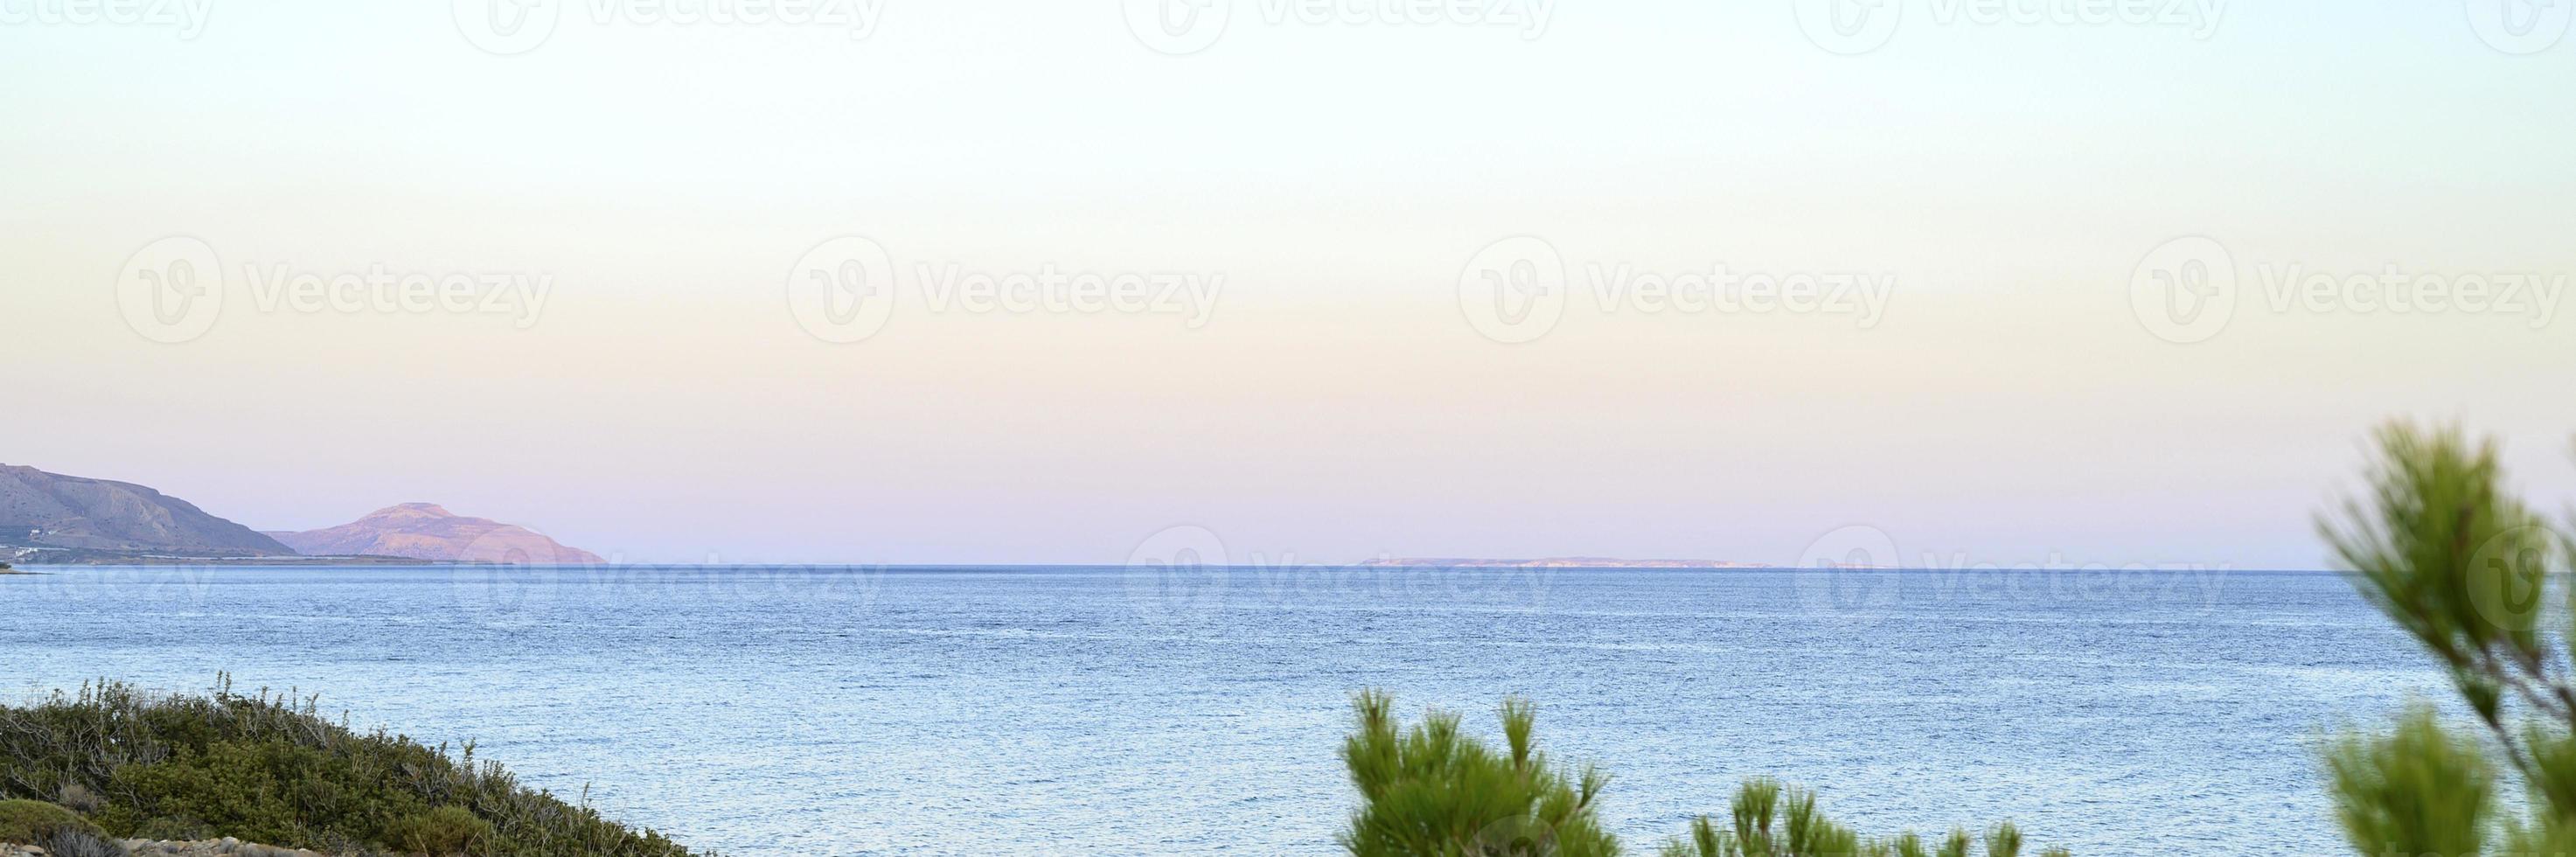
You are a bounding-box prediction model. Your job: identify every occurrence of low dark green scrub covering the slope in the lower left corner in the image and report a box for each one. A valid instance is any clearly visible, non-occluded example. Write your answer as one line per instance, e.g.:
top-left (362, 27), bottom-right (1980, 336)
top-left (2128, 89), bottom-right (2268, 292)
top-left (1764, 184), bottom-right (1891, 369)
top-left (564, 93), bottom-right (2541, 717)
top-left (0, 682), bottom-right (688, 857)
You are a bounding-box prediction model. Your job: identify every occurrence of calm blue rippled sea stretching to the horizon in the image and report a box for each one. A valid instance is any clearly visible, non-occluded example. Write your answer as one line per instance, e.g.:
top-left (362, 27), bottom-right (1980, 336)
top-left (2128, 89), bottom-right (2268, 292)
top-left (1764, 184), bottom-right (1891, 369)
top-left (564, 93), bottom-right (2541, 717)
top-left (0, 568), bottom-right (2440, 854)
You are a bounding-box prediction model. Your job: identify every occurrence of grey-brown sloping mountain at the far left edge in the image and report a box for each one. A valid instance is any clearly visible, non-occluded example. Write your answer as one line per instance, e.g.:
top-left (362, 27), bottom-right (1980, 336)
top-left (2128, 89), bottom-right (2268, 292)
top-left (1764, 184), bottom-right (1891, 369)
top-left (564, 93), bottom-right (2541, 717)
top-left (0, 463), bottom-right (296, 556)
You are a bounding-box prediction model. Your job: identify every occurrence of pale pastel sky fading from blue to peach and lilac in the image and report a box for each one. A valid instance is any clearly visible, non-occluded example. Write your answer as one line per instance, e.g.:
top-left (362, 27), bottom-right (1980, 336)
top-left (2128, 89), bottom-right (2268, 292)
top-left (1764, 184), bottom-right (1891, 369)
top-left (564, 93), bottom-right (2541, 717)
top-left (0, 0), bottom-right (2576, 568)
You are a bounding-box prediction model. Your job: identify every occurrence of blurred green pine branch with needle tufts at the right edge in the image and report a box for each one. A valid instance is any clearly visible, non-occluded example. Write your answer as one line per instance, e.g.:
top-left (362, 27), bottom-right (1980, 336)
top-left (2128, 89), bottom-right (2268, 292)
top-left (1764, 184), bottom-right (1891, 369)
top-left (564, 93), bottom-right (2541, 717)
top-left (2318, 425), bottom-right (2576, 857)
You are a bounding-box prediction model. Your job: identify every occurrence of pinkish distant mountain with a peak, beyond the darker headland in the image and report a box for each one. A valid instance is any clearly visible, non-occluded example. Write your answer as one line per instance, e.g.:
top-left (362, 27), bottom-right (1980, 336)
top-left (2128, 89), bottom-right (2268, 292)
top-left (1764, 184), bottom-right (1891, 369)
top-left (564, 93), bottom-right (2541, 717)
top-left (268, 502), bottom-right (605, 566)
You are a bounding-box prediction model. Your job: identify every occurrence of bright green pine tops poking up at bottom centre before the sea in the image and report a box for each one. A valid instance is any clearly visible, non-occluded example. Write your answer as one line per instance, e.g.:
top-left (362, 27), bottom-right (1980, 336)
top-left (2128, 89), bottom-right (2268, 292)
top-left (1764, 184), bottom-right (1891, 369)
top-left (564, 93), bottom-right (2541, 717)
top-left (1340, 693), bottom-right (2066, 857)
